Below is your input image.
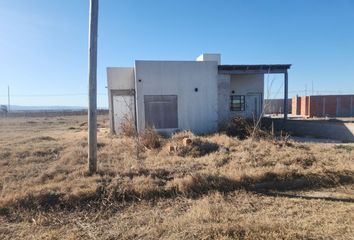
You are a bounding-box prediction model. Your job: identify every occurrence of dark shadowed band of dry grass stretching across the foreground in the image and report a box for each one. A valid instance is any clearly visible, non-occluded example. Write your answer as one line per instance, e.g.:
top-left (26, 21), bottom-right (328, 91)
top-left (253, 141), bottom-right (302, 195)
top-left (0, 170), bottom-right (354, 217)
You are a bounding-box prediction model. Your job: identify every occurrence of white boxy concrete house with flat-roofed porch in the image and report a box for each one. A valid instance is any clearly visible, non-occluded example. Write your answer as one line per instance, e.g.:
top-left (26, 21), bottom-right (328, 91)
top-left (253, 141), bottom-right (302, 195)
top-left (107, 54), bottom-right (291, 134)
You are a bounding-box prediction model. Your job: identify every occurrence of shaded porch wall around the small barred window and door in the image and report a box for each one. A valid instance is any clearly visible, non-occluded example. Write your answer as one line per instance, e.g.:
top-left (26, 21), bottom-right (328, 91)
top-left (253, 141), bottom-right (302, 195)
top-left (229, 74), bottom-right (264, 118)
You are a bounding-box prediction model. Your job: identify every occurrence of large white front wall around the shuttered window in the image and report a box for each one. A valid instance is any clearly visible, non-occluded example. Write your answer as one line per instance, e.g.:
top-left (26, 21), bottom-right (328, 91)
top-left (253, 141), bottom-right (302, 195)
top-left (135, 61), bottom-right (218, 133)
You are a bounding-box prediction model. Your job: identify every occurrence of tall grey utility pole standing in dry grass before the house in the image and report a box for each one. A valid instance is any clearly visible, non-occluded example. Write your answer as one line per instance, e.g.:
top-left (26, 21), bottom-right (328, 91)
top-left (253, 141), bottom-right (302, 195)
top-left (88, 0), bottom-right (98, 174)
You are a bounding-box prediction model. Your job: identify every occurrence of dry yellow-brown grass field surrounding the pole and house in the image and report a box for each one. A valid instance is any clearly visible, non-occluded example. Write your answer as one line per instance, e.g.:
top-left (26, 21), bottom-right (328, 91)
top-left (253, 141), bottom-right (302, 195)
top-left (0, 116), bottom-right (354, 239)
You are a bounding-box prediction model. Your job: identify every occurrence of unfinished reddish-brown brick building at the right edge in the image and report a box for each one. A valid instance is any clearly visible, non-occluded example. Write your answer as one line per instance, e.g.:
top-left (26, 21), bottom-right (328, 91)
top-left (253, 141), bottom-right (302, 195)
top-left (292, 95), bottom-right (354, 117)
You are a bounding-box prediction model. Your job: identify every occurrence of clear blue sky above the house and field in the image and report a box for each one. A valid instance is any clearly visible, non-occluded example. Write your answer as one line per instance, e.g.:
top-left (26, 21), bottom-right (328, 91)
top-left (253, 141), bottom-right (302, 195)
top-left (0, 0), bottom-right (354, 107)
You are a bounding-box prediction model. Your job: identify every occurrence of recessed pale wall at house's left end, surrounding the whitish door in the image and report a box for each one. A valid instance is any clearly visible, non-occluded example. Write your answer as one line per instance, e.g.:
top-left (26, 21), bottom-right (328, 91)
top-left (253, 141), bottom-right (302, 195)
top-left (107, 67), bottom-right (135, 133)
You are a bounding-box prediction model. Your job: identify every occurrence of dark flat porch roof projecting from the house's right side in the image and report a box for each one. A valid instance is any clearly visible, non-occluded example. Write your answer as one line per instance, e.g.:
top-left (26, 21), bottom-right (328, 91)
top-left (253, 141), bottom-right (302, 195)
top-left (218, 64), bottom-right (291, 74)
